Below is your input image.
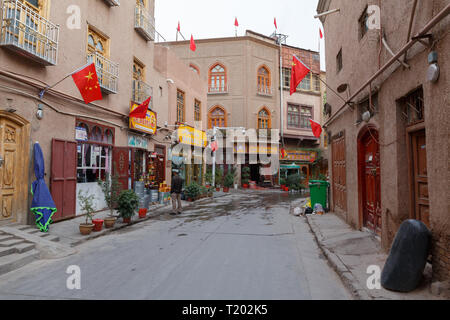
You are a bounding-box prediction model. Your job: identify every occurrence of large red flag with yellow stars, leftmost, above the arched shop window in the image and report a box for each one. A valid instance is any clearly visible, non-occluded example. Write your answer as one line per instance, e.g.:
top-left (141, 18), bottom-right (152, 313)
top-left (72, 63), bottom-right (103, 104)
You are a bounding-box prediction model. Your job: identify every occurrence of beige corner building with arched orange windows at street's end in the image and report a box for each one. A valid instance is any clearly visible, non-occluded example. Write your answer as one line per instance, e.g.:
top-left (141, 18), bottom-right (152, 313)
top-left (159, 31), bottom-right (322, 184)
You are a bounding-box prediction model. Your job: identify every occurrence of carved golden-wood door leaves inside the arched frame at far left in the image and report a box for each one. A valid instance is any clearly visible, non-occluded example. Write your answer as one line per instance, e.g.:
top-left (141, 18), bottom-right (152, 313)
top-left (0, 117), bottom-right (24, 222)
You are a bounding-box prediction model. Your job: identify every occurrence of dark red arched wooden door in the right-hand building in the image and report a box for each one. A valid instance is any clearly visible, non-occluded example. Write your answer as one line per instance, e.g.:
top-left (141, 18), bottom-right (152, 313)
top-left (359, 129), bottom-right (381, 235)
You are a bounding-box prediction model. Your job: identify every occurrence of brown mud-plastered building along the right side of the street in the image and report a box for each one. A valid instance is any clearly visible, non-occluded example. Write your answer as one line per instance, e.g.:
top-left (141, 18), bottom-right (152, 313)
top-left (317, 0), bottom-right (450, 280)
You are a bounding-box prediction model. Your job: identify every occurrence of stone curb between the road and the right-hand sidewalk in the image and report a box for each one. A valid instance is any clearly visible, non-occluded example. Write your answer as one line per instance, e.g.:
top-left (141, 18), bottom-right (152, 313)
top-left (306, 215), bottom-right (372, 300)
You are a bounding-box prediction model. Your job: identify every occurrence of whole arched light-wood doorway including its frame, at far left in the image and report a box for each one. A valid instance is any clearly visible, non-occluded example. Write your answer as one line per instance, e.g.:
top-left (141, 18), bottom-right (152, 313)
top-left (0, 111), bottom-right (29, 224)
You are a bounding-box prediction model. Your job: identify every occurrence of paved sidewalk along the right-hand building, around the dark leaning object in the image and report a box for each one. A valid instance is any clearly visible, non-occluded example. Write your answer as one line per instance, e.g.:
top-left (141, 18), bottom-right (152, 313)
top-left (303, 213), bottom-right (441, 300)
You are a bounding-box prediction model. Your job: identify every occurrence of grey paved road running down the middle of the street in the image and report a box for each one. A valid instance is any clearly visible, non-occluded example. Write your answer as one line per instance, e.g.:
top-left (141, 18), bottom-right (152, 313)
top-left (0, 191), bottom-right (351, 300)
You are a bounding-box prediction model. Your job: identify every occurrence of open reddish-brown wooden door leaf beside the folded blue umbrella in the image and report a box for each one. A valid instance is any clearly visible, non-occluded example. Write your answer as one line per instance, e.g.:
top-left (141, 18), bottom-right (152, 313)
top-left (50, 139), bottom-right (77, 221)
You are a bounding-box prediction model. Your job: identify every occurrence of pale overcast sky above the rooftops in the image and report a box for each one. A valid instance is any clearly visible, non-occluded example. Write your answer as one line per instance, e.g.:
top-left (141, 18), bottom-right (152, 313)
top-left (155, 0), bottom-right (325, 70)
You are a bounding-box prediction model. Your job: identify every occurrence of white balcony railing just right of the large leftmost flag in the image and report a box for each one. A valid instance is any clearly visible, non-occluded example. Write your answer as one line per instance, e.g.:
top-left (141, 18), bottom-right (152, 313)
top-left (87, 52), bottom-right (119, 93)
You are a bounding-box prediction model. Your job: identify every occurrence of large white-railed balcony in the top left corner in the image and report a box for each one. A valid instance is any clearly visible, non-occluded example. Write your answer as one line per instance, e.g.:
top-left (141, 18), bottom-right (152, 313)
top-left (0, 0), bottom-right (59, 66)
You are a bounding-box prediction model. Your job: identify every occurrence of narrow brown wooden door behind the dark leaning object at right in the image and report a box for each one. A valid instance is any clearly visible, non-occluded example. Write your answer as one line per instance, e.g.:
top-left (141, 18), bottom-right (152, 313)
top-left (410, 130), bottom-right (431, 228)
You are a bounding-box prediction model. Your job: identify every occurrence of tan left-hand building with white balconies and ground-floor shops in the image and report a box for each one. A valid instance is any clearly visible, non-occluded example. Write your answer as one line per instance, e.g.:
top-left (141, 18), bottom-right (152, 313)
top-left (0, 0), bottom-right (206, 224)
